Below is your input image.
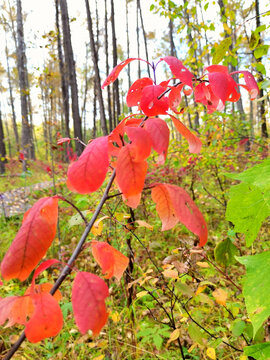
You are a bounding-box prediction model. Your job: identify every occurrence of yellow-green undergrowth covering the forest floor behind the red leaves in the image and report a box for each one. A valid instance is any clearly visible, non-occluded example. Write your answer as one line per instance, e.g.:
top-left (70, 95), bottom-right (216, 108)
top-left (0, 127), bottom-right (269, 360)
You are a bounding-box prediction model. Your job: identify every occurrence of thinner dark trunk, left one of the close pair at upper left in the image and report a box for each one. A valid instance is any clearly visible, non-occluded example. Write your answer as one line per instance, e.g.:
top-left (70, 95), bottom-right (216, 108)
top-left (55, 0), bottom-right (71, 138)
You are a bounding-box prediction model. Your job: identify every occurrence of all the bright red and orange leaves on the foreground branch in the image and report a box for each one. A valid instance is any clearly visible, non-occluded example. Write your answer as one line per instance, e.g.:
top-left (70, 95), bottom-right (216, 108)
top-left (0, 56), bottom-right (259, 342)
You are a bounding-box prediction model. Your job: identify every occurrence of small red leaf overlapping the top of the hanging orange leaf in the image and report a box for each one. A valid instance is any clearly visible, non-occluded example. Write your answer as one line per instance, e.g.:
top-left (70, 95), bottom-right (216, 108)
top-left (125, 126), bottom-right (152, 162)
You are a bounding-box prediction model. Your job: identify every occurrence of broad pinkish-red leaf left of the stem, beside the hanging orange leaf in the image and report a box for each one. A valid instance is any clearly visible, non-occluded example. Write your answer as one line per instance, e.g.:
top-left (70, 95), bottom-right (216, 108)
top-left (67, 136), bottom-right (109, 194)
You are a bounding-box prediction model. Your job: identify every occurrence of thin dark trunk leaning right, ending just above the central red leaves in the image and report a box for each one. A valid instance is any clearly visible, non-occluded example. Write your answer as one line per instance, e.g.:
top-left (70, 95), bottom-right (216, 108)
top-left (85, 0), bottom-right (108, 135)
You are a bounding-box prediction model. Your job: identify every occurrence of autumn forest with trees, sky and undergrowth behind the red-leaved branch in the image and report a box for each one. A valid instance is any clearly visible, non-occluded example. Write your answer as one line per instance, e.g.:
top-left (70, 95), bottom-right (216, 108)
top-left (0, 0), bottom-right (270, 360)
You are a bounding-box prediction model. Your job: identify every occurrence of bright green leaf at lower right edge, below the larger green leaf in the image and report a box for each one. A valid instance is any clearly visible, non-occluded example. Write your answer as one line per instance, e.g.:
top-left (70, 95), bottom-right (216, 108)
top-left (236, 251), bottom-right (270, 338)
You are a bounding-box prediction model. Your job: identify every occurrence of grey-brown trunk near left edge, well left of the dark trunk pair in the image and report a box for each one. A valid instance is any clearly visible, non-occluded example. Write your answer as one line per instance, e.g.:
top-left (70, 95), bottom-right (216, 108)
top-left (17, 0), bottom-right (34, 159)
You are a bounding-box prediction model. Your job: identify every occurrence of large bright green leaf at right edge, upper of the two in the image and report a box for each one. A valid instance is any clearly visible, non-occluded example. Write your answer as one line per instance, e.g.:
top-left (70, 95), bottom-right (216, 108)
top-left (226, 159), bottom-right (270, 246)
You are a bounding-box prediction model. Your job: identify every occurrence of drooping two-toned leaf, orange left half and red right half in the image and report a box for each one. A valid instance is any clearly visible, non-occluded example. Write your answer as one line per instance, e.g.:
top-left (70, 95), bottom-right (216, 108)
top-left (152, 184), bottom-right (208, 246)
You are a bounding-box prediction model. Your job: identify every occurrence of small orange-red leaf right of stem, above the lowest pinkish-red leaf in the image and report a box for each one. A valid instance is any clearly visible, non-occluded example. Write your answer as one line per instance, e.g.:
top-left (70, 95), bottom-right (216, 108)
top-left (91, 241), bottom-right (129, 281)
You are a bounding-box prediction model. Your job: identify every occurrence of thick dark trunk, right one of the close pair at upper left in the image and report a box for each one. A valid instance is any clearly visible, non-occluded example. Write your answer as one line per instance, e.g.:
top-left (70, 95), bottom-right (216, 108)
top-left (60, 0), bottom-right (83, 155)
